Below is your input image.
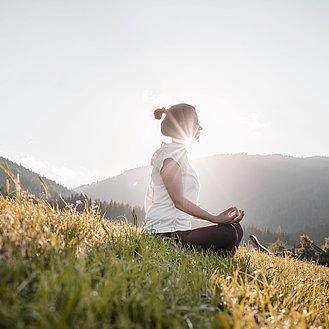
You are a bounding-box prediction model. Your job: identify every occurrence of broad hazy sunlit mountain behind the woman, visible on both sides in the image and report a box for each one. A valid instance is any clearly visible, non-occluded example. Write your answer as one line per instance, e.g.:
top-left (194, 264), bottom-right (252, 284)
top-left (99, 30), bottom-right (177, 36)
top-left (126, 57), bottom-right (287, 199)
top-left (77, 154), bottom-right (329, 243)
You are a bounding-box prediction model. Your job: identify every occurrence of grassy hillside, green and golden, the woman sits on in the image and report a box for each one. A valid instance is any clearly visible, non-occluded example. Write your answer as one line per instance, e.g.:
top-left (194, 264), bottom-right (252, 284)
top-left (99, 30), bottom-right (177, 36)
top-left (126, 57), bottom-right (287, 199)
top-left (0, 193), bottom-right (329, 328)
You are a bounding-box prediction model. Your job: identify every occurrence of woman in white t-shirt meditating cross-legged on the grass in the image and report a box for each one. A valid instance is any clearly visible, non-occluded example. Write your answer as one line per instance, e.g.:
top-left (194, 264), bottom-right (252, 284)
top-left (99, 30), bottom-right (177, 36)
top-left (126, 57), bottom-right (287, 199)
top-left (145, 104), bottom-right (244, 255)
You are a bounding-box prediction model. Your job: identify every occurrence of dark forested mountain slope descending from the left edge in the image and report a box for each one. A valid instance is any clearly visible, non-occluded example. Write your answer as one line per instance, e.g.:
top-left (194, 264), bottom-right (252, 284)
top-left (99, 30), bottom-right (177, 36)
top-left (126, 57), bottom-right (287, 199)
top-left (0, 157), bottom-right (75, 197)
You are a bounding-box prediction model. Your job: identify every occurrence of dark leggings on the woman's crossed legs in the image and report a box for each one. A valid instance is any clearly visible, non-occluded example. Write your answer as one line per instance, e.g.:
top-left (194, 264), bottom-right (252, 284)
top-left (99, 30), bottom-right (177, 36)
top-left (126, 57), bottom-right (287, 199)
top-left (157, 223), bottom-right (243, 256)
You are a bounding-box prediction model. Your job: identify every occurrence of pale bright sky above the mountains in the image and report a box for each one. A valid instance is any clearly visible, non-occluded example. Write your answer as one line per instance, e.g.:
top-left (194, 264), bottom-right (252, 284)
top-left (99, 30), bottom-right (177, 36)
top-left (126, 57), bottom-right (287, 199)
top-left (0, 0), bottom-right (329, 188)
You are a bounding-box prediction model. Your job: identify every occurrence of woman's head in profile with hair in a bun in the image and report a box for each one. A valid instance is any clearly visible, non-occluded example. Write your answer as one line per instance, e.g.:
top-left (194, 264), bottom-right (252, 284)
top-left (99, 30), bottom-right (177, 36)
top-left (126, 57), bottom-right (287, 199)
top-left (154, 104), bottom-right (202, 140)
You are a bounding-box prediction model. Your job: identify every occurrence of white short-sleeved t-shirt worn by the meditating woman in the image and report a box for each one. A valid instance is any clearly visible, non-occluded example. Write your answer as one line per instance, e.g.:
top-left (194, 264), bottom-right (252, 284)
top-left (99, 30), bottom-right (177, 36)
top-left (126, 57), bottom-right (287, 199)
top-left (145, 143), bottom-right (199, 233)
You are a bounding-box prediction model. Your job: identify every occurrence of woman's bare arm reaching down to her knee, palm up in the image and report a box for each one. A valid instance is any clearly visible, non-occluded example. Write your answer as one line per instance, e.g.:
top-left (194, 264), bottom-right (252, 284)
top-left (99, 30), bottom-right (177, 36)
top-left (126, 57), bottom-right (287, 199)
top-left (160, 158), bottom-right (244, 224)
